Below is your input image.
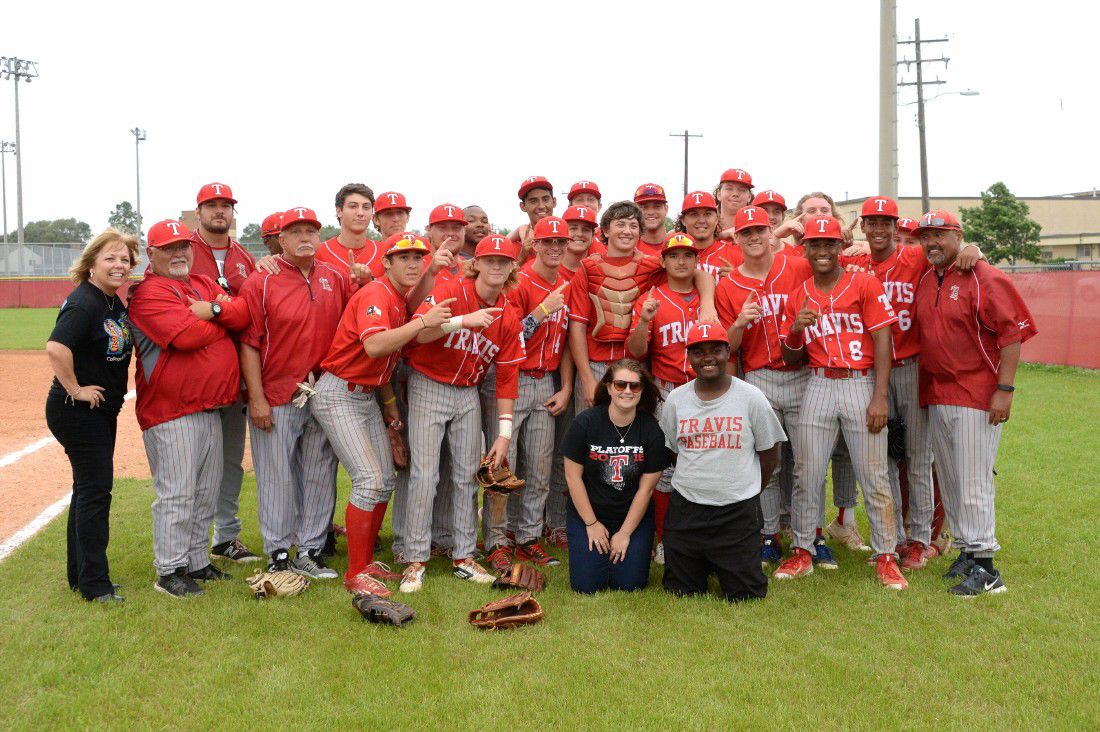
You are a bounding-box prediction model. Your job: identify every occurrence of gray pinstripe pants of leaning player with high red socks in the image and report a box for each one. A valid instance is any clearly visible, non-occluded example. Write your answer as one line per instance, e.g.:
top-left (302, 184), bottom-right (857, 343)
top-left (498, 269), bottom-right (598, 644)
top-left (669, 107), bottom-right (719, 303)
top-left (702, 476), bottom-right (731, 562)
top-left (309, 372), bottom-right (396, 511)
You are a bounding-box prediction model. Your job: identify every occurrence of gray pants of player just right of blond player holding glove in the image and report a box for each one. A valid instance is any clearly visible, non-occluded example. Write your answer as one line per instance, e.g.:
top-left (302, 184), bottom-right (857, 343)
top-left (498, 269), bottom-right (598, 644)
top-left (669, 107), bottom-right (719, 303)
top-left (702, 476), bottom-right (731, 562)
top-left (481, 371), bottom-right (556, 541)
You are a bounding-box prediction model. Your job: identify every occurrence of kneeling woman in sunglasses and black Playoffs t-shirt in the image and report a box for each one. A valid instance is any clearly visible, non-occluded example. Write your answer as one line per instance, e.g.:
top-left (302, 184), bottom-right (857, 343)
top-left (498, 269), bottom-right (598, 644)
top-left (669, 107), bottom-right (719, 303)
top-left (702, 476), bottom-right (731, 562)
top-left (561, 359), bottom-right (668, 593)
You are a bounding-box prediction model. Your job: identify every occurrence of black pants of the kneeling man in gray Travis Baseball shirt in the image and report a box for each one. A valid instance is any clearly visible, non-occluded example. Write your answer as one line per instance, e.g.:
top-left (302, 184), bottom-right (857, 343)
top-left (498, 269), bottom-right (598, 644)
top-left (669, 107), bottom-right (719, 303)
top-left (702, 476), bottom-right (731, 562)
top-left (664, 491), bottom-right (768, 602)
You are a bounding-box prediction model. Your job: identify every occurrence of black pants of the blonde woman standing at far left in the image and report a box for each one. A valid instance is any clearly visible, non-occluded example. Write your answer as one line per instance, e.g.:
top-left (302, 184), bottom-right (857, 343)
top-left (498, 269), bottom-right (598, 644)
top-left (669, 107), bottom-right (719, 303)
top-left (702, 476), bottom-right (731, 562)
top-left (46, 392), bottom-right (118, 600)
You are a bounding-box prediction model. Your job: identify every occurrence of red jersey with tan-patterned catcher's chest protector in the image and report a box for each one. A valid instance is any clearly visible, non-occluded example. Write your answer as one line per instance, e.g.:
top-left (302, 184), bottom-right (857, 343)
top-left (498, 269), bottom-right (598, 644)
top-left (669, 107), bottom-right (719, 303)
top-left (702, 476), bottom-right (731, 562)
top-left (567, 251), bottom-right (666, 362)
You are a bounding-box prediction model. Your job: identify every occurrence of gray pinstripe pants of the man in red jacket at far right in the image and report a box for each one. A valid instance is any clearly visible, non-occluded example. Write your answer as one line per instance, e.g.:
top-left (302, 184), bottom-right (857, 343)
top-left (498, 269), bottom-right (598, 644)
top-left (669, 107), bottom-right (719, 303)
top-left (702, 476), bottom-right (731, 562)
top-left (928, 404), bottom-right (1002, 558)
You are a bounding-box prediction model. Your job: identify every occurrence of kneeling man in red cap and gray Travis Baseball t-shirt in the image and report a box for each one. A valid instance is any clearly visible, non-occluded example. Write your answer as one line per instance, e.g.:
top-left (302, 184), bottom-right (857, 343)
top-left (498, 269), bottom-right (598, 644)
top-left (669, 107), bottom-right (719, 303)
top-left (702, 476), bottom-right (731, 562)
top-left (661, 323), bottom-right (787, 601)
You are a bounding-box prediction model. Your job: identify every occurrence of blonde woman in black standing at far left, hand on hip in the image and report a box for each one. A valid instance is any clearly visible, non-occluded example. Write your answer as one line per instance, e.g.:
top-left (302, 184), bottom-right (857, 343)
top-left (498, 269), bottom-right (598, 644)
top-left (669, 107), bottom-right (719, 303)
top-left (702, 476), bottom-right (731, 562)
top-left (46, 229), bottom-right (138, 602)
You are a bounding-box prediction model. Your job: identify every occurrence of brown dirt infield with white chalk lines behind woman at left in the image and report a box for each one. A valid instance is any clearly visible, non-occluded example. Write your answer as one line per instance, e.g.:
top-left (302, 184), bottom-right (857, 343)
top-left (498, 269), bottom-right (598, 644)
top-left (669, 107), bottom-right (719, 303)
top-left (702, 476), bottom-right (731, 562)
top-left (0, 351), bottom-right (251, 540)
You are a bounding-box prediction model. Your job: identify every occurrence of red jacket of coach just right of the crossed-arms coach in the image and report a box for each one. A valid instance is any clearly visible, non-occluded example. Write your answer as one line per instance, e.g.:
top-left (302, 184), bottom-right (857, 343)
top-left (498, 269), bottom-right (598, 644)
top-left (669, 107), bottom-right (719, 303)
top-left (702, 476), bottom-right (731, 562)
top-left (241, 255), bottom-right (348, 406)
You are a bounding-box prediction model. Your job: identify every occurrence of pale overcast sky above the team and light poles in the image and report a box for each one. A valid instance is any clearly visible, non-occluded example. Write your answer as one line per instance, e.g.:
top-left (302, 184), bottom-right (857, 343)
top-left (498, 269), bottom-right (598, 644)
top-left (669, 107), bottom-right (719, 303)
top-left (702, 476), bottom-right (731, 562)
top-left (0, 0), bottom-right (1100, 234)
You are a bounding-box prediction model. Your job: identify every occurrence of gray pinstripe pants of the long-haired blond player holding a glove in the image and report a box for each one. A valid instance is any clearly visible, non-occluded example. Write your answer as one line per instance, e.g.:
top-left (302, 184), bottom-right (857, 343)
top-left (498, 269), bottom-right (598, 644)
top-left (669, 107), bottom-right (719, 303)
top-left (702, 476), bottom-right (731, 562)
top-left (404, 370), bottom-right (482, 561)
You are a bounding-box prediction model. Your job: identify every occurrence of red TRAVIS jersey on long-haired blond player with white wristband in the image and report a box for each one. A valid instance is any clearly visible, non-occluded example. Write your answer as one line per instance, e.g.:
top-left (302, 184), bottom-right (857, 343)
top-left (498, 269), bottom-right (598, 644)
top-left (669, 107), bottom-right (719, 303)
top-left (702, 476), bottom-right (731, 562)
top-left (407, 277), bottom-right (527, 398)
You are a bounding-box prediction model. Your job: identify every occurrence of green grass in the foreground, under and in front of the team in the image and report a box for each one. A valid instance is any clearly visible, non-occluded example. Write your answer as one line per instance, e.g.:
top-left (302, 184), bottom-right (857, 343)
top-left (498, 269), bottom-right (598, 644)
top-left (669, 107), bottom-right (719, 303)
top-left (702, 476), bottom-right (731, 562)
top-left (0, 367), bottom-right (1100, 730)
